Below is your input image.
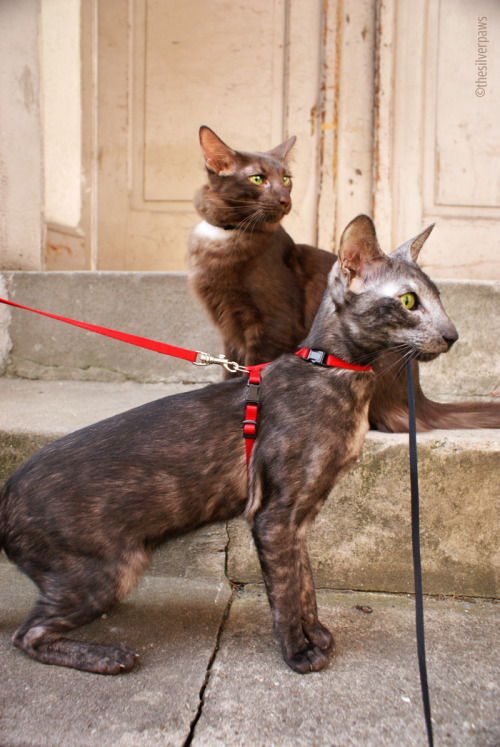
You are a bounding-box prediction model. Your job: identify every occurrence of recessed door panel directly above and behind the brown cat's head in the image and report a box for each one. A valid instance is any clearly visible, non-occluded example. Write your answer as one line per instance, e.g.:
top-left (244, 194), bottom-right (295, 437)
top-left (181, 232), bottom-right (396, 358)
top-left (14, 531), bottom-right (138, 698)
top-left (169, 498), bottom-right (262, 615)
top-left (139, 0), bottom-right (285, 208)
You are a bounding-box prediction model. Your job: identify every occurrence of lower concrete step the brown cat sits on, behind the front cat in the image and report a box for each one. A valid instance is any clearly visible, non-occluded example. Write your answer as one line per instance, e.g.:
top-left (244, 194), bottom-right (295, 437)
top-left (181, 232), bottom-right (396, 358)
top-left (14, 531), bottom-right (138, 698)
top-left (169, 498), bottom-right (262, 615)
top-left (0, 377), bottom-right (500, 597)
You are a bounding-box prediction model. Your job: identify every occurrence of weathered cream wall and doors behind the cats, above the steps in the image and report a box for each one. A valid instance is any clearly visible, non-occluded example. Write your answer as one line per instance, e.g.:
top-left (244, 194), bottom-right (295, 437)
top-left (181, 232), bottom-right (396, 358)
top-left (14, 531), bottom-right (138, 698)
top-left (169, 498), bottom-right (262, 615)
top-left (0, 0), bottom-right (500, 279)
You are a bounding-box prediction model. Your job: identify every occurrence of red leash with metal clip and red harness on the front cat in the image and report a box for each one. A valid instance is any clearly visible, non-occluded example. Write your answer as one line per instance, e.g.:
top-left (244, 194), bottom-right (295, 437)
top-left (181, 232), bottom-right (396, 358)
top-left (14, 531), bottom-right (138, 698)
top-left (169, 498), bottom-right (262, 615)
top-left (0, 298), bottom-right (372, 471)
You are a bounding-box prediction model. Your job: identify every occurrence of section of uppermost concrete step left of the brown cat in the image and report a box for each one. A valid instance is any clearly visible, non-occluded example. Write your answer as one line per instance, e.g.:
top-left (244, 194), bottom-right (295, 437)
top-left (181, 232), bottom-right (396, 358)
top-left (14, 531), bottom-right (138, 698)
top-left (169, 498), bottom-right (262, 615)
top-left (0, 272), bottom-right (222, 383)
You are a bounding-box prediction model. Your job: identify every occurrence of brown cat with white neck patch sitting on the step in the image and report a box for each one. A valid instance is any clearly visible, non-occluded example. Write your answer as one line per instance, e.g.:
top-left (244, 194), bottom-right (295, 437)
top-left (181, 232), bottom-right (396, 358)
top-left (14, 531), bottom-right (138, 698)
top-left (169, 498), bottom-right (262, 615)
top-left (189, 127), bottom-right (500, 432)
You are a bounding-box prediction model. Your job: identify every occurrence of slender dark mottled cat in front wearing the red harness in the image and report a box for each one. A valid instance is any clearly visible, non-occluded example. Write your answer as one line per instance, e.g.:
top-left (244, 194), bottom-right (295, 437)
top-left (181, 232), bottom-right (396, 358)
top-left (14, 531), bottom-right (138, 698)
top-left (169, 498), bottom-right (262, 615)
top-left (0, 216), bottom-right (457, 674)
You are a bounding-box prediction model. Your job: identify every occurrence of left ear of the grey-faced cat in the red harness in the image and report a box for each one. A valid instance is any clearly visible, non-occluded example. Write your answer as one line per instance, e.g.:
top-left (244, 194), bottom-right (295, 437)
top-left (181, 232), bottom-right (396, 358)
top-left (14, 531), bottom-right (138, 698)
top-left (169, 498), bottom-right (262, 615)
top-left (339, 215), bottom-right (385, 283)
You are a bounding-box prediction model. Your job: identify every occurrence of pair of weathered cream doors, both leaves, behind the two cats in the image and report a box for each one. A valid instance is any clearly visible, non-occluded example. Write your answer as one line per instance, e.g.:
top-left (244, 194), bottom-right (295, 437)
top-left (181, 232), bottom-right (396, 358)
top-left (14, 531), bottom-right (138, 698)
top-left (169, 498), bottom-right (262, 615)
top-left (47, 0), bottom-right (500, 278)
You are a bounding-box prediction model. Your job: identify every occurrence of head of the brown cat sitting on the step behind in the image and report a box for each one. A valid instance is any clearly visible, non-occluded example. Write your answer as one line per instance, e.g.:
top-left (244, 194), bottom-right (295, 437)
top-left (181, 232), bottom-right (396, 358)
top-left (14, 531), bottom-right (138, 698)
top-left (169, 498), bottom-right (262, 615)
top-left (195, 126), bottom-right (296, 229)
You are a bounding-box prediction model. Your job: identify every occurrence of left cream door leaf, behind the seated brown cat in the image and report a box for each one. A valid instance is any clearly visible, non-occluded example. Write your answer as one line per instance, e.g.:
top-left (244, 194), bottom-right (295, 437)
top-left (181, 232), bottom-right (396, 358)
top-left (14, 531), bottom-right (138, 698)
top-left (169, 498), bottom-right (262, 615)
top-left (97, 0), bottom-right (322, 270)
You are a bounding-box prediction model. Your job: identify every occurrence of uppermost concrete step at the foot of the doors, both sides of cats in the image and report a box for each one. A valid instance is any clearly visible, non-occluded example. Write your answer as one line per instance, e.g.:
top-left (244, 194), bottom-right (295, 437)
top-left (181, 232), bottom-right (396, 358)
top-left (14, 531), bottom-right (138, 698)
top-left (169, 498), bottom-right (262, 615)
top-left (0, 272), bottom-right (500, 400)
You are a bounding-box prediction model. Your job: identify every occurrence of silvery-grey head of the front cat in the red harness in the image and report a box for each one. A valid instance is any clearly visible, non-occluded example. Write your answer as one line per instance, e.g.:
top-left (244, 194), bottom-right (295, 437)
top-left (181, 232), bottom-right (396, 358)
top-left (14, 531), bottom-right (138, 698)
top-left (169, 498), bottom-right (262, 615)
top-left (329, 215), bottom-right (458, 361)
